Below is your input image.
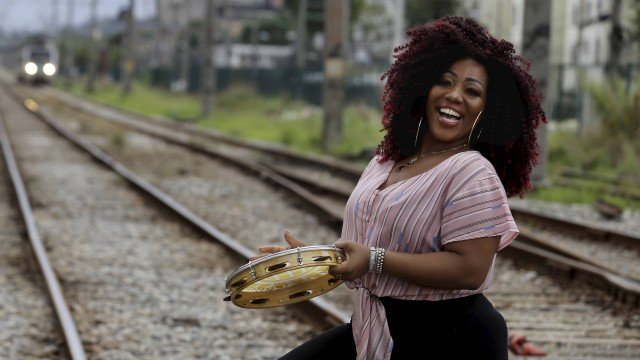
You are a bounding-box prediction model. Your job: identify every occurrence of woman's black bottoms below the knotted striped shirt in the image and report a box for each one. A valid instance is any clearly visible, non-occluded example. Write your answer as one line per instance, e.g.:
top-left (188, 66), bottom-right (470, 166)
top-left (281, 294), bottom-right (508, 360)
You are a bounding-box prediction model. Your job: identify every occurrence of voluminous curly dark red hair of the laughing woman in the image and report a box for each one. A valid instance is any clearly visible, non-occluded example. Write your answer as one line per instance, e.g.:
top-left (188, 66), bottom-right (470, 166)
top-left (376, 16), bottom-right (546, 197)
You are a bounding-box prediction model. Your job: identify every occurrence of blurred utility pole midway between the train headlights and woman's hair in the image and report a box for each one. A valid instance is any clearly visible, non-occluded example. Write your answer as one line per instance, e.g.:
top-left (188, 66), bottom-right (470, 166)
top-left (201, 0), bottom-right (218, 118)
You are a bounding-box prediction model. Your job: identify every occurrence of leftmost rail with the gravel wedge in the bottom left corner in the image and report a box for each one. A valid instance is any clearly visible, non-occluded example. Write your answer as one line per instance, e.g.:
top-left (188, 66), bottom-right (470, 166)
top-left (0, 114), bottom-right (77, 359)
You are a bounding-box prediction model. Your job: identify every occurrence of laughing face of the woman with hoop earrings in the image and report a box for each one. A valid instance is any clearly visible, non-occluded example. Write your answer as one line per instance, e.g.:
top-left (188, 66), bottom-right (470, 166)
top-left (425, 59), bottom-right (489, 144)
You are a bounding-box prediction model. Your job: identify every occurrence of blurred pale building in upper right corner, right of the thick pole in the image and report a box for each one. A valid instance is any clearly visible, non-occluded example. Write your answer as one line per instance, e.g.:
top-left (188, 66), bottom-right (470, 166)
top-left (548, 0), bottom-right (640, 126)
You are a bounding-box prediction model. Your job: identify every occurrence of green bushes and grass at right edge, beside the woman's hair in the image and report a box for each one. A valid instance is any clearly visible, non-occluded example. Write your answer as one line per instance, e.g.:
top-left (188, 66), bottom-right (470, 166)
top-left (530, 76), bottom-right (640, 209)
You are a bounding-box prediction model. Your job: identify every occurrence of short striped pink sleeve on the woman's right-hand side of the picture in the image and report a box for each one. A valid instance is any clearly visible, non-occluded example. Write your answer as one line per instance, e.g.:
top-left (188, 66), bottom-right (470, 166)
top-left (440, 161), bottom-right (519, 250)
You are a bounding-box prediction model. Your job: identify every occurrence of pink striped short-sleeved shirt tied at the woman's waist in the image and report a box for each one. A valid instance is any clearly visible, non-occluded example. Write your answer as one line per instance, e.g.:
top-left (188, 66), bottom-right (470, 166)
top-left (341, 151), bottom-right (518, 360)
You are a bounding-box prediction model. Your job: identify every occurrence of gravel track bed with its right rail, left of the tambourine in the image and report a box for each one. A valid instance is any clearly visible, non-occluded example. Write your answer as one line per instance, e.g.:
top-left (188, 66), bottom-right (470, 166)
top-left (0, 84), bottom-right (345, 359)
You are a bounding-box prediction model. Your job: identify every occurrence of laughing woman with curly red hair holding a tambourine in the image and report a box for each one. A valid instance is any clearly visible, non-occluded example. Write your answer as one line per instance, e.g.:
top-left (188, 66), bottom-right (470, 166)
top-left (255, 17), bottom-right (545, 359)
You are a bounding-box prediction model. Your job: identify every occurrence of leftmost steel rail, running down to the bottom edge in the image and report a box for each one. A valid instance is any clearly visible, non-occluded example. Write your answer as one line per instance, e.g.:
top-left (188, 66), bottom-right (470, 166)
top-left (0, 98), bottom-right (87, 360)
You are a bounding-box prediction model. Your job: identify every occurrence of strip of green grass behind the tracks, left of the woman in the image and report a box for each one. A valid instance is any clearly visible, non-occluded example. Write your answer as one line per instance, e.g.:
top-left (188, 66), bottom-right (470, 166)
top-left (63, 83), bottom-right (383, 158)
